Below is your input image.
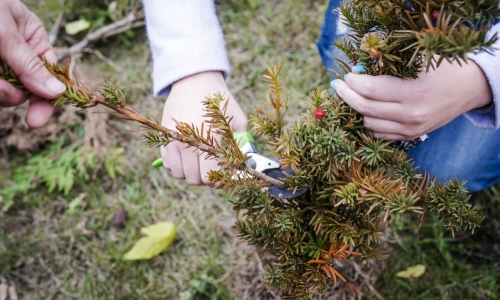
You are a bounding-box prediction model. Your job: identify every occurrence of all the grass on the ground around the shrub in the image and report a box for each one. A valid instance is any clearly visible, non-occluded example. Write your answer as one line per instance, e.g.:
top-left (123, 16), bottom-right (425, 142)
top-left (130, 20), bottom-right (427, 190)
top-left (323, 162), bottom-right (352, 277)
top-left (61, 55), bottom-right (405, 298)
top-left (0, 0), bottom-right (500, 299)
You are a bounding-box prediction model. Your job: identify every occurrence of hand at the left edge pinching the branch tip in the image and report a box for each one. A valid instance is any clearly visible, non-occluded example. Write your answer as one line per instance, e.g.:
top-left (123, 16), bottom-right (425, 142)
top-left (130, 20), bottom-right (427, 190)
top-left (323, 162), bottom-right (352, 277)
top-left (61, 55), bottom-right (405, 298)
top-left (0, 0), bottom-right (66, 128)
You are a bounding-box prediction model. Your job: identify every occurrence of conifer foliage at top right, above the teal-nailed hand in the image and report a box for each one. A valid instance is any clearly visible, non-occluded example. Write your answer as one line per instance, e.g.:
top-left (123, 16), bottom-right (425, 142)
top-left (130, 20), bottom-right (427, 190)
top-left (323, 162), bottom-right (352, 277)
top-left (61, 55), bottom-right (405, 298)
top-left (335, 0), bottom-right (500, 78)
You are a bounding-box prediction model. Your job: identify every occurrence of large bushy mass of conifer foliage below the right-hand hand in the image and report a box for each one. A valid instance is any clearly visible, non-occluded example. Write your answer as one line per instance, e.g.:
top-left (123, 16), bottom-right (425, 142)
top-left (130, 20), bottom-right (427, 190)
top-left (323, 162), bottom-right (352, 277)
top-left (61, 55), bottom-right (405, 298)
top-left (229, 67), bottom-right (482, 298)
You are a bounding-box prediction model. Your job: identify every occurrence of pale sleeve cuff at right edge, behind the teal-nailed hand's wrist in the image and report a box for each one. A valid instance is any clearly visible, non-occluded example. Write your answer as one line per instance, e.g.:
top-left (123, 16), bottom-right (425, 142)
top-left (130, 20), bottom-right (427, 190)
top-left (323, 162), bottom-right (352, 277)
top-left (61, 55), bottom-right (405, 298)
top-left (465, 23), bottom-right (500, 129)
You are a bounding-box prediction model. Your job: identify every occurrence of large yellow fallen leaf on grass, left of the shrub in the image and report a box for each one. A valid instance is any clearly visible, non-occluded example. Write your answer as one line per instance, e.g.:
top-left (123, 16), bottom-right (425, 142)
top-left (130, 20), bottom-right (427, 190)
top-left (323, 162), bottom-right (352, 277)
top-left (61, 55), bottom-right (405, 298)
top-left (123, 222), bottom-right (177, 260)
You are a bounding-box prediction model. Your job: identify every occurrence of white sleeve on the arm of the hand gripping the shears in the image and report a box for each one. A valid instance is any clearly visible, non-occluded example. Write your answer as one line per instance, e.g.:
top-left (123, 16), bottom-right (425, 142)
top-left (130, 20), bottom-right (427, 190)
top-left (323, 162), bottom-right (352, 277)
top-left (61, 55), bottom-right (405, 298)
top-left (143, 0), bottom-right (230, 96)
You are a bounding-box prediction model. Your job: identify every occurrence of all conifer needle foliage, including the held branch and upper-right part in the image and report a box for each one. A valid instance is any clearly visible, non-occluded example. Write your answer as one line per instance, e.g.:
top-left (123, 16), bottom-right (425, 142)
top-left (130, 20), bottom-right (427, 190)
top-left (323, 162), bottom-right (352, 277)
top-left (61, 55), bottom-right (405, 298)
top-left (0, 0), bottom-right (500, 299)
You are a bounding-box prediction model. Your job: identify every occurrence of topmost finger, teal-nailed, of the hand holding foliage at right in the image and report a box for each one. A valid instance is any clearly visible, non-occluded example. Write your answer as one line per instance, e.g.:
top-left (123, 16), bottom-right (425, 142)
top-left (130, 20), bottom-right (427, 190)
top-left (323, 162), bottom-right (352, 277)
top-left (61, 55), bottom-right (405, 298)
top-left (344, 73), bottom-right (410, 102)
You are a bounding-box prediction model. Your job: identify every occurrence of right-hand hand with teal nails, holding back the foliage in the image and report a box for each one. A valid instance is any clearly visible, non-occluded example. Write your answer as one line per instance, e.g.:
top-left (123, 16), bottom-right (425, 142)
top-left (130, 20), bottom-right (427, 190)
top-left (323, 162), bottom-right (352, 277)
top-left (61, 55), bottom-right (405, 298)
top-left (331, 60), bottom-right (493, 140)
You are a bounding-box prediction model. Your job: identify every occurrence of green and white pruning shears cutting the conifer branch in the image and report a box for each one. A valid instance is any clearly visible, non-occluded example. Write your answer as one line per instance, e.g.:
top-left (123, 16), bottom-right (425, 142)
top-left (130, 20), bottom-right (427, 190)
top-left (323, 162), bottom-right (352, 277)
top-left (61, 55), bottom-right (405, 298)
top-left (152, 132), bottom-right (308, 199)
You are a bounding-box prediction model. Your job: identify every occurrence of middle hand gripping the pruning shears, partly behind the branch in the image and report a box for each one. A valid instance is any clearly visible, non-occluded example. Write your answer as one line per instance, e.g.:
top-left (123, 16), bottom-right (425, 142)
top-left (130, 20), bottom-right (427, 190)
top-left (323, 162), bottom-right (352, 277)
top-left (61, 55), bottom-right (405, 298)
top-left (161, 71), bottom-right (248, 185)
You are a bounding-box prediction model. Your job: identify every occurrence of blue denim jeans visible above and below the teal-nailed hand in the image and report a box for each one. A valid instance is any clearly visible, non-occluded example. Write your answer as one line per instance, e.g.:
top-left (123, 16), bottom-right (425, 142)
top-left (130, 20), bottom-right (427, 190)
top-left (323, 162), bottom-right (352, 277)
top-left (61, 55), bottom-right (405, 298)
top-left (317, 0), bottom-right (500, 192)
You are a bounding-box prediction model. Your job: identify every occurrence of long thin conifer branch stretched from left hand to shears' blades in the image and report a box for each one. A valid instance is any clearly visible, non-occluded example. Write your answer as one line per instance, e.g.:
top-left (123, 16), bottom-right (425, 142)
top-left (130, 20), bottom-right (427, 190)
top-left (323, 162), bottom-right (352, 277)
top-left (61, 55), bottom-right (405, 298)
top-left (0, 58), bottom-right (286, 188)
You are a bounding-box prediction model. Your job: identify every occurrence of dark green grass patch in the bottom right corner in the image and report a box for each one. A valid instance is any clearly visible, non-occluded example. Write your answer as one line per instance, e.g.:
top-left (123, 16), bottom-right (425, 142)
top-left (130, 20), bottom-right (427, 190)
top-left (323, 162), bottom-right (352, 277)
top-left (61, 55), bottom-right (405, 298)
top-left (377, 189), bottom-right (500, 299)
